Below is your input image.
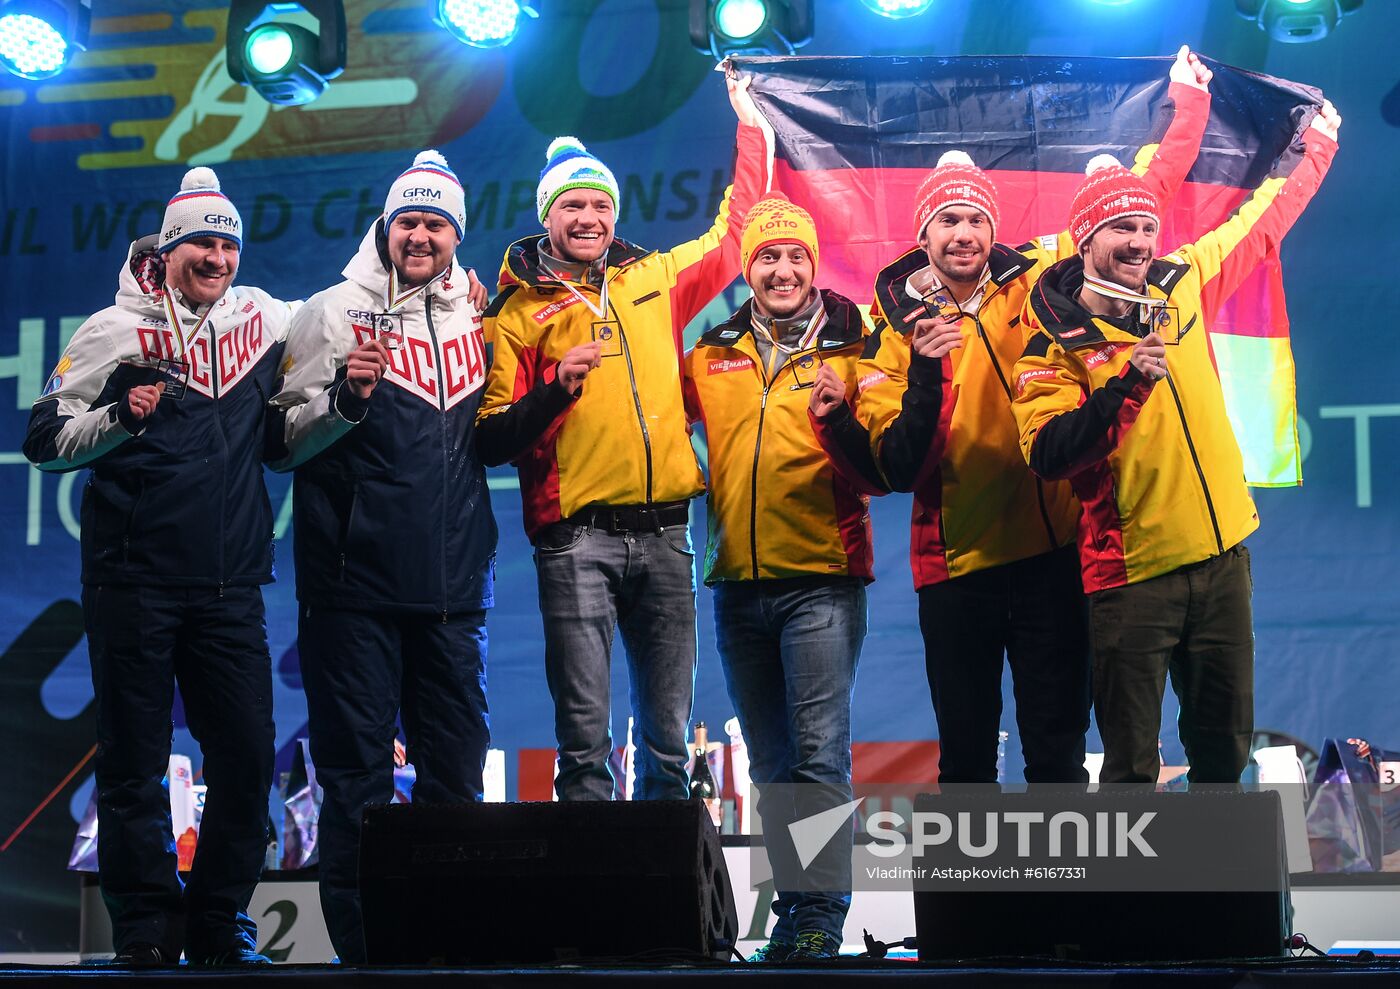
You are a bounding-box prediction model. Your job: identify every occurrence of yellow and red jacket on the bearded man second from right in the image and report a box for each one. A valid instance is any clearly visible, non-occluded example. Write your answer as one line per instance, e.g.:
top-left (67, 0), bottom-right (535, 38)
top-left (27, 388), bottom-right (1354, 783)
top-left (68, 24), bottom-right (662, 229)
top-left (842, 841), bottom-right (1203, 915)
top-left (855, 83), bottom-right (1210, 588)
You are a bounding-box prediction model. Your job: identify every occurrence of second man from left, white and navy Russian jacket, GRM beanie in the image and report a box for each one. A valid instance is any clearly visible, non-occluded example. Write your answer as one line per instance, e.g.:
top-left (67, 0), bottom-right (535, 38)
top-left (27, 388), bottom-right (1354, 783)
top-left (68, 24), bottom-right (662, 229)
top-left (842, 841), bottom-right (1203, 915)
top-left (269, 151), bottom-right (496, 962)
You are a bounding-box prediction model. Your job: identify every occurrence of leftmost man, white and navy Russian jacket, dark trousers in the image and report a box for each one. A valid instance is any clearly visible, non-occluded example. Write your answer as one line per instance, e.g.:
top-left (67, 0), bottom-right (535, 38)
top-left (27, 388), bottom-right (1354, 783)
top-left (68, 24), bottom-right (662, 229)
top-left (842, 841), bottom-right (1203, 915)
top-left (24, 168), bottom-right (291, 965)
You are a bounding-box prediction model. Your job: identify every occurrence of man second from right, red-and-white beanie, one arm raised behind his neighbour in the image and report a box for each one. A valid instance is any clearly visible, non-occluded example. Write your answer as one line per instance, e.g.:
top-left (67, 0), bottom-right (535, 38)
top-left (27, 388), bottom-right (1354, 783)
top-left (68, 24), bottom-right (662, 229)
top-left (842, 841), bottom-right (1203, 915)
top-left (840, 48), bottom-right (1211, 783)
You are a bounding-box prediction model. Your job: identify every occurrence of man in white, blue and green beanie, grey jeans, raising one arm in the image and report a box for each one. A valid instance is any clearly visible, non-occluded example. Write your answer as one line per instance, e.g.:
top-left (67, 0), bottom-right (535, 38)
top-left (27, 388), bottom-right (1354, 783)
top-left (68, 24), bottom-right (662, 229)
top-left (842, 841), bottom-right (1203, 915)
top-left (477, 78), bottom-right (769, 800)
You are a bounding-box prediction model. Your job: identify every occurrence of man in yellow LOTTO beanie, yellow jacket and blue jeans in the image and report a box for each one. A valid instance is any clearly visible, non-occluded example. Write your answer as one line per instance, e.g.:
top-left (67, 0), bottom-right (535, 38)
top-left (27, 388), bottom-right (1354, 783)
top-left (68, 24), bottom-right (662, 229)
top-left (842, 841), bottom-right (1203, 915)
top-left (685, 193), bottom-right (874, 961)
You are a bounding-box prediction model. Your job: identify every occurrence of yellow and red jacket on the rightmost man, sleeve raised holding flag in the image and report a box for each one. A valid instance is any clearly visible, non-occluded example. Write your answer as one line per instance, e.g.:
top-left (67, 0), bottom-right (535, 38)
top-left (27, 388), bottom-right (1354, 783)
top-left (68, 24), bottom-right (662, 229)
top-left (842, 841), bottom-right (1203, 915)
top-left (1014, 121), bottom-right (1337, 591)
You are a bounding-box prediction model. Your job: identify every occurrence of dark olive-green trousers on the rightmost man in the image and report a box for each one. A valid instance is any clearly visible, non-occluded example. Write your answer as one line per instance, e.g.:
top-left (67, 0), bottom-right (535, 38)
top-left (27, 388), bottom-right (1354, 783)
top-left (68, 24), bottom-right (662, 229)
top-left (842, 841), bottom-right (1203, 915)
top-left (1089, 545), bottom-right (1254, 784)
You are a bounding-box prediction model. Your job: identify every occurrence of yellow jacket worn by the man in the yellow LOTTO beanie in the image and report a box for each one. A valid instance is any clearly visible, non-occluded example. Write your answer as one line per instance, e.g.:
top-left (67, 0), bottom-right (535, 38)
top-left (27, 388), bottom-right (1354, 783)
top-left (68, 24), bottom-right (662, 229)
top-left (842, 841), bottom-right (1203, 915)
top-left (685, 291), bottom-right (874, 584)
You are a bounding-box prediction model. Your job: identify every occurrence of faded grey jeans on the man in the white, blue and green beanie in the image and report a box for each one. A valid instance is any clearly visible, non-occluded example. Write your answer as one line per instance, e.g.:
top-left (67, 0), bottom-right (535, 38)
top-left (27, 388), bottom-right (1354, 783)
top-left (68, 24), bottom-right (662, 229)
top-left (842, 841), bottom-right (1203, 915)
top-left (535, 523), bottom-right (696, 800)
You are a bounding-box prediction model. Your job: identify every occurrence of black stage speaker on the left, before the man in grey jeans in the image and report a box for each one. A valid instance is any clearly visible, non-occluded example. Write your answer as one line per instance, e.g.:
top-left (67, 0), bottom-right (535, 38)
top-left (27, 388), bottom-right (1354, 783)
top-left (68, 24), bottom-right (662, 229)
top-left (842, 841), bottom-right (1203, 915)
top-left (360, 800), bottom-right (739, 965)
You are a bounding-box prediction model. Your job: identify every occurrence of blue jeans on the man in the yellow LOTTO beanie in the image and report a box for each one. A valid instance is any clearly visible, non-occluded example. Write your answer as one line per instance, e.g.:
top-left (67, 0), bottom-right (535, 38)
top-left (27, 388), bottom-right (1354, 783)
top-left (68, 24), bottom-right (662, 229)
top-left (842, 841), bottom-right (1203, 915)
top-left (714, 577), bottom-right (865, 944)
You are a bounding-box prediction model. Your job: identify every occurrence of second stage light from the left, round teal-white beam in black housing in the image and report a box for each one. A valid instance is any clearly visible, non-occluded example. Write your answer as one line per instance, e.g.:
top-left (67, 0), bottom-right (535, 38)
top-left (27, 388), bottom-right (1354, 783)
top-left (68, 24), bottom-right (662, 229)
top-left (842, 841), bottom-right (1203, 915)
top-left (225, 0), bottom-right (346, 106)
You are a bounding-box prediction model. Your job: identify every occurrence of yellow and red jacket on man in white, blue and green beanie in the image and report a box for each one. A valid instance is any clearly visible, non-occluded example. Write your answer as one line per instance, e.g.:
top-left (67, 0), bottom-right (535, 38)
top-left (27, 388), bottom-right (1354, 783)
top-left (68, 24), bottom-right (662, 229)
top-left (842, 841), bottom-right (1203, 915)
top-left (477, 125), bottom-right (767, 539)
